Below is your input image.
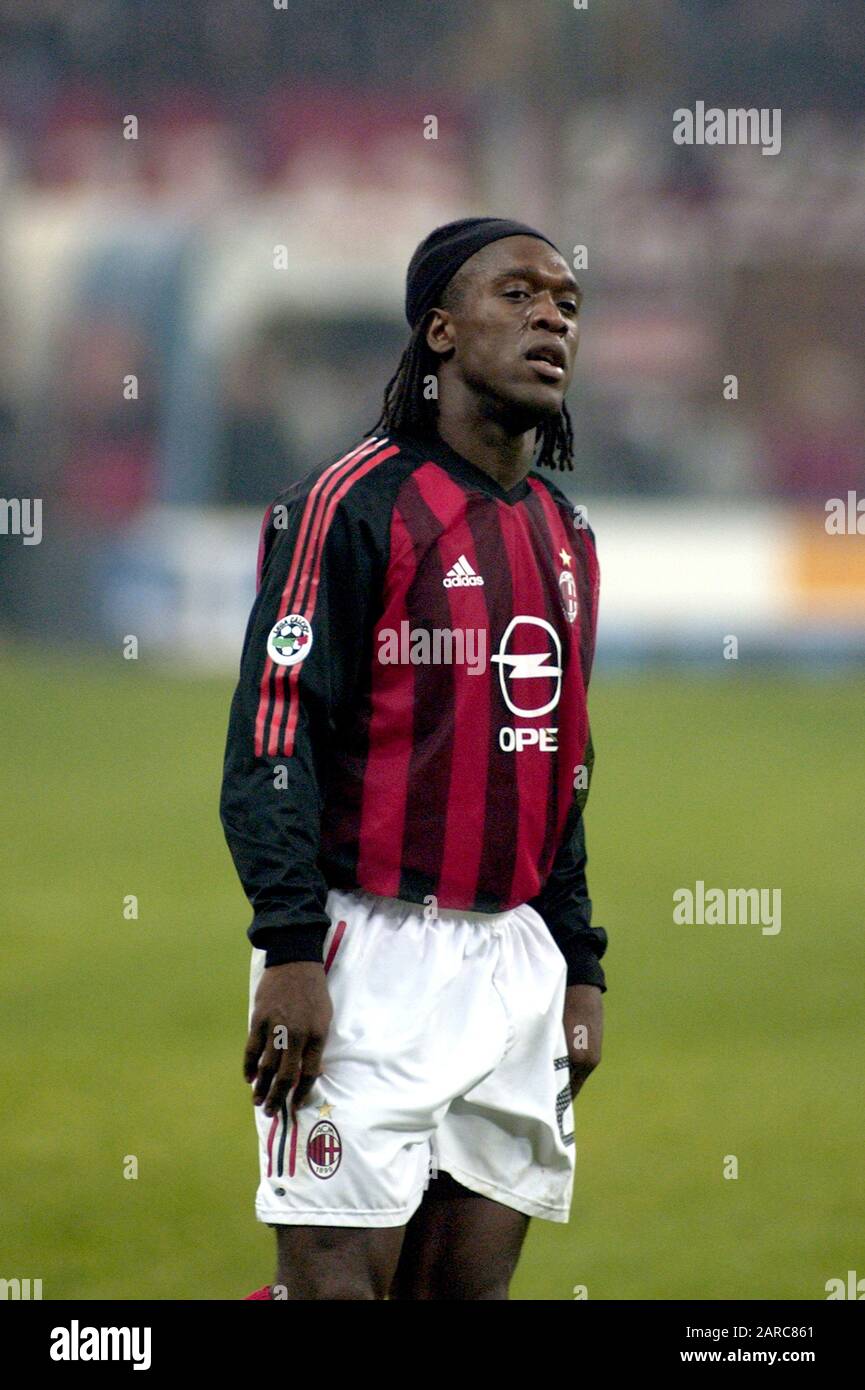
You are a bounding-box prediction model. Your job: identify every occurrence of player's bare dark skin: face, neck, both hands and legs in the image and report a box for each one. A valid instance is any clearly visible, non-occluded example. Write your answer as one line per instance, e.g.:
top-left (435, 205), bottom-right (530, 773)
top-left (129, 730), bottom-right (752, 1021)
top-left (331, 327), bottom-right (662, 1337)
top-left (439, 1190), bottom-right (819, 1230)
top-left (243, 236), bottom-right (604, 1301)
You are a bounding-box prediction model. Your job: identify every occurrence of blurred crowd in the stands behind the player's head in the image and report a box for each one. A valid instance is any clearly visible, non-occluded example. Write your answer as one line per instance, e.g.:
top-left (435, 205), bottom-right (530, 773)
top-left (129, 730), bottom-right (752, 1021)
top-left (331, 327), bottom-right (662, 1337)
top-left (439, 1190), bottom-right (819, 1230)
top-left (0, 0), bottom-right (865, 636)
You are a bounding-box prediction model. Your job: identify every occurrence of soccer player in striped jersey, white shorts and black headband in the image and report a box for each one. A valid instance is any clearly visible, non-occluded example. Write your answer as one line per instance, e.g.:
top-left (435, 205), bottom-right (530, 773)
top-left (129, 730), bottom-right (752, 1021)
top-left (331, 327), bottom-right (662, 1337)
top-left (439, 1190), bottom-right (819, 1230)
top-left (221, 218), bottom-right (606, 1300)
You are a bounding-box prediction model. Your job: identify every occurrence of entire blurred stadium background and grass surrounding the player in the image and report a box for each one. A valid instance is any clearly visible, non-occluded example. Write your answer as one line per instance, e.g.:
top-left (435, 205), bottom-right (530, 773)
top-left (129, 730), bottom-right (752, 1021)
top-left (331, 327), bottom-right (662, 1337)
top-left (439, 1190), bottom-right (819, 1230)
top-left (0, 0), bottom-right (865, 1300)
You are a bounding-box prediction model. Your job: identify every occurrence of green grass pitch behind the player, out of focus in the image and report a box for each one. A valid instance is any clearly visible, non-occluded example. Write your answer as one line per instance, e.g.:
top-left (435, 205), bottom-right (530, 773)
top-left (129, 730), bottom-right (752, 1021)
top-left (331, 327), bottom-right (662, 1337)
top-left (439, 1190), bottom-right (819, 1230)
top-left (0, 648), bottom-right (865, 1300)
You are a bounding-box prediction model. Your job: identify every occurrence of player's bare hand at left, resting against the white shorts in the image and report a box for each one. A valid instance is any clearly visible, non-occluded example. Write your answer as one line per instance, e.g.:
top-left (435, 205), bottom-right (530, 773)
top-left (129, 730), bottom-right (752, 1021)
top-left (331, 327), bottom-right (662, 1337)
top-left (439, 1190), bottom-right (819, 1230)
top-left (243, 960), bottom-right (334, 1122)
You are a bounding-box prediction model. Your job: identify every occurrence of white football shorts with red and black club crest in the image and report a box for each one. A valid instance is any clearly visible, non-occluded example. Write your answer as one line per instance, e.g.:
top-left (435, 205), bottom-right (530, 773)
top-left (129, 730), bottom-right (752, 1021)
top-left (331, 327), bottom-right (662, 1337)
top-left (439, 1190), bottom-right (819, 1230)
top-left (249, 890), bottom-right (574, 1226)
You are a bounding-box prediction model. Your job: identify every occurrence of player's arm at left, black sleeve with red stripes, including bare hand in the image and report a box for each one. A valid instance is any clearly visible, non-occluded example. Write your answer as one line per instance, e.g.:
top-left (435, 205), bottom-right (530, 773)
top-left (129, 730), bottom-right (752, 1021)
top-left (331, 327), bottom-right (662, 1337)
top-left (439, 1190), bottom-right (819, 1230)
top-left (220, 489), bottom-right (375, 1113)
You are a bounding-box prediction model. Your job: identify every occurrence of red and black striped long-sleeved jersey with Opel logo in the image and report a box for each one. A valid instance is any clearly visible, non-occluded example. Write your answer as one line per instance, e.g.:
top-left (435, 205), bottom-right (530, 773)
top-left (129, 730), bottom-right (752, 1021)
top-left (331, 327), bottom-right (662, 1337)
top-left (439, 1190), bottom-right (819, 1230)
top-left (221, 435), bottom-right (606, 990)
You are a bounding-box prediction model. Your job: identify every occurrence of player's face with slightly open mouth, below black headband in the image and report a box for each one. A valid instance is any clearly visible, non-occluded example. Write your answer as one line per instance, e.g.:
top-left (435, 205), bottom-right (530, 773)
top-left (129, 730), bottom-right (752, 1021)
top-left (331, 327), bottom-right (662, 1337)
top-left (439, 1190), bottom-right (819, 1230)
top-left (431, 236), bottom-right (583, 427)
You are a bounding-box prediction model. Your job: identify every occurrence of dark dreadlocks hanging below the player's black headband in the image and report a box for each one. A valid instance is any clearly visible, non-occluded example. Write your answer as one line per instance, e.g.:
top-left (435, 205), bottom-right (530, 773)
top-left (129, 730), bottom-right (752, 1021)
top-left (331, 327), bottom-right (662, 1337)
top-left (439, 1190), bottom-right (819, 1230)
top-left (367, 303), bottom-right (574, 470)
